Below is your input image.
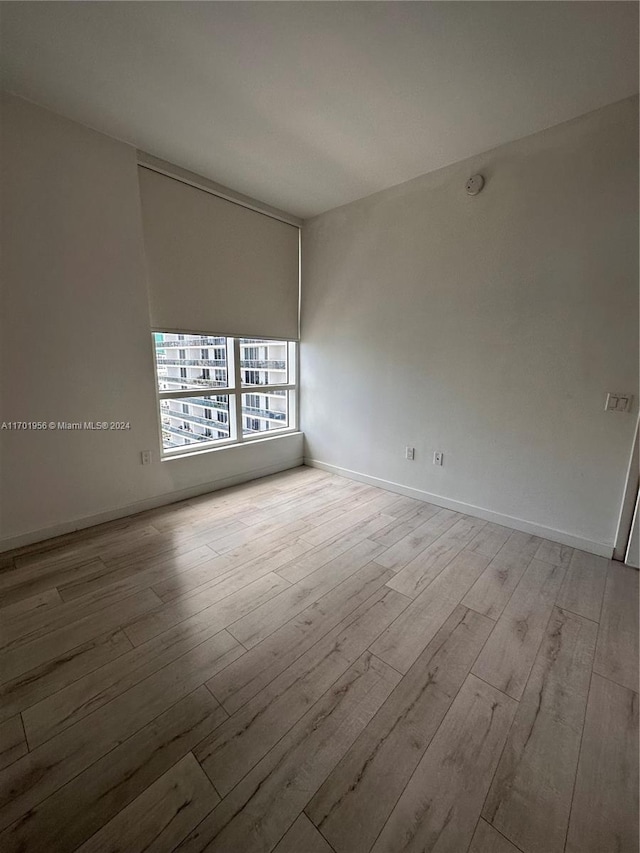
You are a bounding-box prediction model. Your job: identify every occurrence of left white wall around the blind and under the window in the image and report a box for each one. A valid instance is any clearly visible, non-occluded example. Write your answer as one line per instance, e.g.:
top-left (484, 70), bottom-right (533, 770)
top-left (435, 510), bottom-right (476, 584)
top-left (0, 96), bottom-right (302, 549)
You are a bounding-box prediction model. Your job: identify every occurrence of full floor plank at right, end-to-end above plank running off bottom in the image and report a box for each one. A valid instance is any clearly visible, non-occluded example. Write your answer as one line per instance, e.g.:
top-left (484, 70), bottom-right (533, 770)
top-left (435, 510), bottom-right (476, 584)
top-left (472, 560), bottom-right (564, 699)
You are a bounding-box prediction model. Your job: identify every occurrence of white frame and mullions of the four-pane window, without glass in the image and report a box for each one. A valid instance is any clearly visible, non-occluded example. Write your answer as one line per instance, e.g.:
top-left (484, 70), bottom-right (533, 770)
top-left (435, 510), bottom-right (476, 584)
top-left (151, 329), bottom-right (299, 461)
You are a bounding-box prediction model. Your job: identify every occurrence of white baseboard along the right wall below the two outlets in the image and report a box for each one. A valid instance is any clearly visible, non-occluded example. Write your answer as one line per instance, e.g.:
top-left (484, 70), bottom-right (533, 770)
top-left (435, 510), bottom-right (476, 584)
top-left (304, 457), bottom-right (613, 559)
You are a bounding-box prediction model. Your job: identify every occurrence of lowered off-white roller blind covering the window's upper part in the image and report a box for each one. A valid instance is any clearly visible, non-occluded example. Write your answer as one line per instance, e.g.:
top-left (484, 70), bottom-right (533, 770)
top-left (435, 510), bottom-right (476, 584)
top-left (138, 166), bottom-right (299, 339)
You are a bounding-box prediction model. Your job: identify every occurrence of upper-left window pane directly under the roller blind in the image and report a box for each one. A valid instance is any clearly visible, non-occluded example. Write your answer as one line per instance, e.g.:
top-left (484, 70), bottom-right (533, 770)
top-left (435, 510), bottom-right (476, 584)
top-left (153, 332), bottom-right (229, 391)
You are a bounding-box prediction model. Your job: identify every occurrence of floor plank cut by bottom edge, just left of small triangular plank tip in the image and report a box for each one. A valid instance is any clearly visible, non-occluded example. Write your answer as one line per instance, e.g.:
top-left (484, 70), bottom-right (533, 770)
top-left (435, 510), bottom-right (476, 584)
top-left (372, 675), bottom-right (517, 853)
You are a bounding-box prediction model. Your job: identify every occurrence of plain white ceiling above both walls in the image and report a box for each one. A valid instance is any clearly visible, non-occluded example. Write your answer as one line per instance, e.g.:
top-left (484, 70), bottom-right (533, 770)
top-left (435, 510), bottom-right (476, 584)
top-left (0, 2), bottom-right (638, 217)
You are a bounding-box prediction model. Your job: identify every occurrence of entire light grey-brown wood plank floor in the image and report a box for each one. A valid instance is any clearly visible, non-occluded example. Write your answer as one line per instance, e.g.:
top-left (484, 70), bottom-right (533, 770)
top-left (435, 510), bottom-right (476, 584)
top-left (0, 468), bottom-right (638, 853)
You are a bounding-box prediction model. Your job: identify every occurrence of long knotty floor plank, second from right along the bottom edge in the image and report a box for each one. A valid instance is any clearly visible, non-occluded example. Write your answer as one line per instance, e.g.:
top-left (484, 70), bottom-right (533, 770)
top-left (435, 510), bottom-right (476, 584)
top-left (483, 609), bottom-right (598, 853)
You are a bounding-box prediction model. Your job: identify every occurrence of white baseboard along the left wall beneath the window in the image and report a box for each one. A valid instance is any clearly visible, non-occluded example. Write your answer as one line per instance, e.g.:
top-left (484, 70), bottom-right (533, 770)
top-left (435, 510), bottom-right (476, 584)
top-left (0, 456), bottom-right (304, 553)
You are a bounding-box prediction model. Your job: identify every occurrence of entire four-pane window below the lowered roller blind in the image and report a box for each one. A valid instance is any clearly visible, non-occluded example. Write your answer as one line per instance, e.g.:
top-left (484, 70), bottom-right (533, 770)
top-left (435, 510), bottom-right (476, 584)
top-left (153, 332), bottom-right (296, 456)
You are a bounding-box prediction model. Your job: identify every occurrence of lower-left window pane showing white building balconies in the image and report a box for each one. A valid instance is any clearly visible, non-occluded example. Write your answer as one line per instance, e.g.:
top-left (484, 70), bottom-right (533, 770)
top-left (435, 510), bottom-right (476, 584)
top-left (160, 394), bottom-right (229, 450)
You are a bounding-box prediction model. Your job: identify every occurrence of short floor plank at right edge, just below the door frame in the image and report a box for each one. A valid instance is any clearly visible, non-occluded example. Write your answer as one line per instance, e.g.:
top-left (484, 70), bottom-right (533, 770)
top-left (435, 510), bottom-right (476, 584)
top-left (593, 560), bottom-right (640, 693)
